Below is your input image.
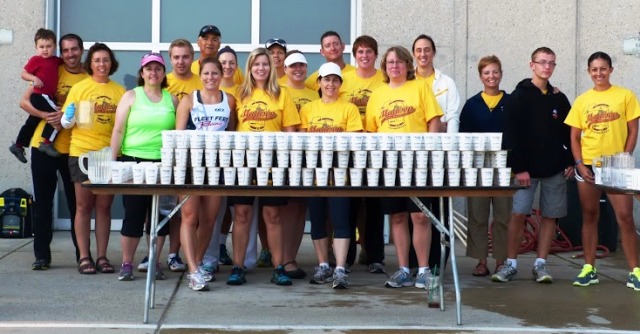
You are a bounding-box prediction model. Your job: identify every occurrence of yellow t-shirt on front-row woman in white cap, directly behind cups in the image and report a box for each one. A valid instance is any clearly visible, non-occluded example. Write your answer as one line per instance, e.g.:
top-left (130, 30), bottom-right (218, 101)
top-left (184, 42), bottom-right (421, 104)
top-left (300, 100), bottom-right (362, 132)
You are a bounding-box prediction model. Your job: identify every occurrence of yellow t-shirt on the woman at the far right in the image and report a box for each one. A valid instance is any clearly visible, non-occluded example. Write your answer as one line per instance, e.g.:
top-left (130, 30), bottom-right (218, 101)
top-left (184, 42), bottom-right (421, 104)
top-left (564, 86), bottom-right (640, 165)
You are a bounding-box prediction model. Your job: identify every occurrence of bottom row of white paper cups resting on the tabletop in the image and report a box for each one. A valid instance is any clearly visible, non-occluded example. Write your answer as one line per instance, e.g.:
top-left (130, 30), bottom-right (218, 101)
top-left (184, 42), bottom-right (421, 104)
top-left (141, 166), bottom-right (511, 187)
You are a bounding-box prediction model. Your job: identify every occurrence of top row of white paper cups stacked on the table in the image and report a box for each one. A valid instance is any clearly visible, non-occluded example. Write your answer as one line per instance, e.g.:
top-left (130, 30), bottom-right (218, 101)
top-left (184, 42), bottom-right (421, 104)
top-left (162, 130), bottom-right (502, 151)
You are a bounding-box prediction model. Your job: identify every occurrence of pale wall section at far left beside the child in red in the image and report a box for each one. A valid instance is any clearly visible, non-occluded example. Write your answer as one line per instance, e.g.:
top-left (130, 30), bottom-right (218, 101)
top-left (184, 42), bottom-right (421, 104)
top-left (0, 0), bottom-right (45, 192)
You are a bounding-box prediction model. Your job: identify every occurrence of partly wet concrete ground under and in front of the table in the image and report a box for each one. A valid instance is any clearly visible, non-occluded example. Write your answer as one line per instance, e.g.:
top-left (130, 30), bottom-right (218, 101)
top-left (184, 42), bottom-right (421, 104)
top-left (0, 231), bottom-right (640, 334)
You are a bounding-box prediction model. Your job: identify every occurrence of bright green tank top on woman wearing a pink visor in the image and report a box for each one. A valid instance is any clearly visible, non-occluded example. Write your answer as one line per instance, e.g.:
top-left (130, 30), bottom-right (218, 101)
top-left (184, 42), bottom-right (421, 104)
top-left (121, 87), bottom-right (176, 160)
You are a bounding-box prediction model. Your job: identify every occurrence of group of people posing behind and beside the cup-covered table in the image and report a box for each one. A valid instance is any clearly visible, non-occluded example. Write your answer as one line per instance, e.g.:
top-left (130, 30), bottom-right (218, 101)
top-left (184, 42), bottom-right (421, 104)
top-left (15, 25), bottom-right (640, 291)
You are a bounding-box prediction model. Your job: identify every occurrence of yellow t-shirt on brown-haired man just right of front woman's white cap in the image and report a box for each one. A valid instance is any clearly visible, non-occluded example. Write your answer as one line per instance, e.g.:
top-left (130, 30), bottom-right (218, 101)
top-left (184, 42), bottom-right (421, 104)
top-left (340, 70), bottom-right (384, 126)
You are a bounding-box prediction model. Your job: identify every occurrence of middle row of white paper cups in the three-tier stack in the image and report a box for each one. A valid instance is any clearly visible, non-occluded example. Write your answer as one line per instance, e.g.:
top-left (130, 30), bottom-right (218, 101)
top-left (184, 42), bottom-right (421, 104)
top-left (161, 148), bottom-right (507, 168)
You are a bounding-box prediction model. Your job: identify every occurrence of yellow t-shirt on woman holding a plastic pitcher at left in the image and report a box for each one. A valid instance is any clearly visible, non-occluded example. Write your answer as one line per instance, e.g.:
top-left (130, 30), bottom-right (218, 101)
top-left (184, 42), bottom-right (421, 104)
top-left (62, 78), bottom-right (125, 157)
